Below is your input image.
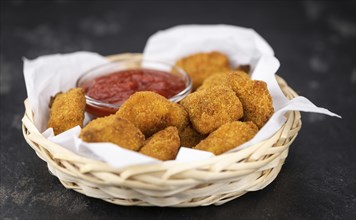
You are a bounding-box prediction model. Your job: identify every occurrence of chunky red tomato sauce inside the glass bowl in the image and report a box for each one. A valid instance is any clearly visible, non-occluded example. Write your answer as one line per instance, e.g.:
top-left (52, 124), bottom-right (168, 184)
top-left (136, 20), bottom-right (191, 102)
top-left (81, 69), bottom-right (185, 116)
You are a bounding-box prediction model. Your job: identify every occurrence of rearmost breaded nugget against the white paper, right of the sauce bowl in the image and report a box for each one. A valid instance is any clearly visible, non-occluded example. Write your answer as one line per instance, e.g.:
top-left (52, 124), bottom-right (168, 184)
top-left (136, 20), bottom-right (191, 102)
top-left (176, 51), bottom-right (230, 90)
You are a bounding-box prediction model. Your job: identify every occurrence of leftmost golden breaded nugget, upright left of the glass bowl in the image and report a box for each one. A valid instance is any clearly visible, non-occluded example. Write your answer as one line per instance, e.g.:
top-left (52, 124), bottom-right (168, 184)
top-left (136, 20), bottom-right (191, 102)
top-left (47, 88), bottom-right (85, 135)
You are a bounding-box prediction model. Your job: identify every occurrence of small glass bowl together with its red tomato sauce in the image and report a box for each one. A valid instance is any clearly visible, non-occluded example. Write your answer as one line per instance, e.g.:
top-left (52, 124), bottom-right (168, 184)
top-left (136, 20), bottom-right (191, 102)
top-left (77, 59), bottom-right (191, 117)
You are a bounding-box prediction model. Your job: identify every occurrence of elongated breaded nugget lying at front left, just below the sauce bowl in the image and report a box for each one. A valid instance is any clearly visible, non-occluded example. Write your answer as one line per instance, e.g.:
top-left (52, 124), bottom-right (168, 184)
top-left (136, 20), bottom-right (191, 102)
top-left (79, 115), bottom-right (145, 151)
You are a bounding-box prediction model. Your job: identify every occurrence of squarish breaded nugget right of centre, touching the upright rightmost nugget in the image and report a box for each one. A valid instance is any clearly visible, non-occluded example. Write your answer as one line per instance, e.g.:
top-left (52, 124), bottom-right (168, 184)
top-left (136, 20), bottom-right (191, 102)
top-left (180, 86), bottom-right (243, 134)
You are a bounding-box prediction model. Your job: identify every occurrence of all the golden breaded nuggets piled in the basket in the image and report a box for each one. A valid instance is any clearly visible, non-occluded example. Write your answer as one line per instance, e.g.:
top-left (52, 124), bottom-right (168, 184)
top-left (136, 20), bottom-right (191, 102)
top-left (48, 52), bottom-right (274, 160)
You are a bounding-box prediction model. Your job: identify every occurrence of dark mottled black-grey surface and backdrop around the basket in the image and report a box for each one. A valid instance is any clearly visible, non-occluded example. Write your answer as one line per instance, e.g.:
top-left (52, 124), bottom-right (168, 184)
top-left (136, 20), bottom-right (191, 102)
top-left (0, 0), bottom-right (356, 219)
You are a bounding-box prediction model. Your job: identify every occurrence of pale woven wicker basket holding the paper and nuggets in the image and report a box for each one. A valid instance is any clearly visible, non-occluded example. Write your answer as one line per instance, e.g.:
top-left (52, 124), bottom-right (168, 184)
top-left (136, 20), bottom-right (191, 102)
top-left (22, 54), bottom-right (301, 207)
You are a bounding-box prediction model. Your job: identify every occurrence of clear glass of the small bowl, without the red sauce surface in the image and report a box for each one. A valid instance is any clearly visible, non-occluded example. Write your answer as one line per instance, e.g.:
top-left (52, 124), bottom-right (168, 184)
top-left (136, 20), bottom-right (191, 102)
top-left (76, 58), bottom-right (192, 117)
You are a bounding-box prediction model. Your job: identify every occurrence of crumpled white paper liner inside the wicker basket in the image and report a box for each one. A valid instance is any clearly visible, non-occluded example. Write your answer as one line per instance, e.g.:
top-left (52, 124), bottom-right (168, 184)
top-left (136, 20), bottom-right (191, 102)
top-left (24, 25), bottom-right (340, 168)
